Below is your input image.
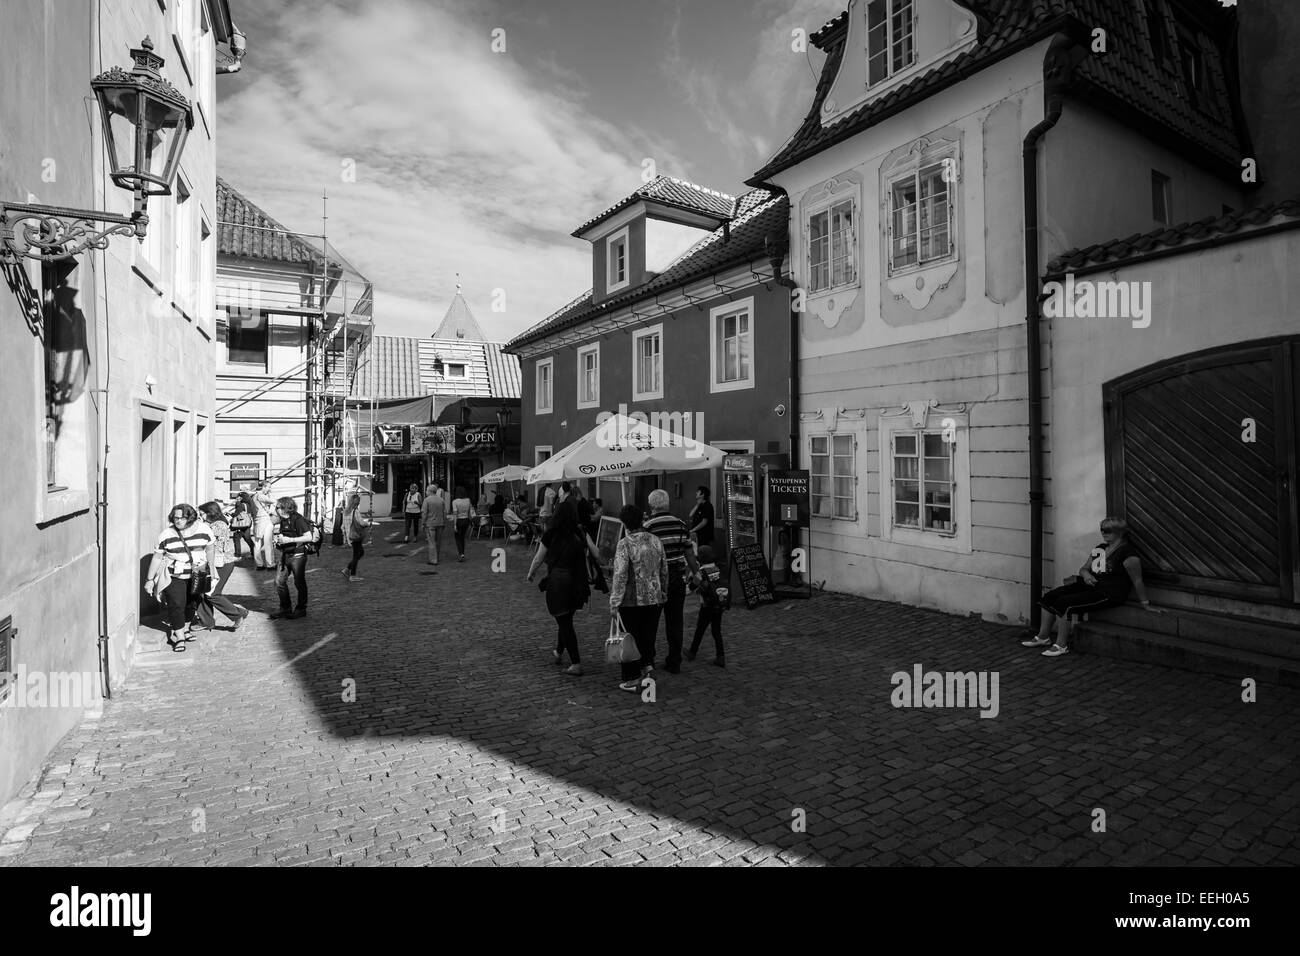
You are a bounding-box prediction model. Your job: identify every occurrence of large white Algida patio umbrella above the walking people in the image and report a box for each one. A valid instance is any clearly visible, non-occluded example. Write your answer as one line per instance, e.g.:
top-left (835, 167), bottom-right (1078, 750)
top-left (524, 415), bottom-right (727, 499)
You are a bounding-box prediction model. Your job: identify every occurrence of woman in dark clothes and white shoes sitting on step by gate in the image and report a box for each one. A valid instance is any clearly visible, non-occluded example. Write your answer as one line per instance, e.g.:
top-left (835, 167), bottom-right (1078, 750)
top-left (1021, 518), bottom-right (1151, 657)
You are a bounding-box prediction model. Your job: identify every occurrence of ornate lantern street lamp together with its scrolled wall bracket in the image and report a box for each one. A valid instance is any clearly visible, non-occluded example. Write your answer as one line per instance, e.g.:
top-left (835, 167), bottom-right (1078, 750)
top-left (0, 36), bottom-right (194, 263)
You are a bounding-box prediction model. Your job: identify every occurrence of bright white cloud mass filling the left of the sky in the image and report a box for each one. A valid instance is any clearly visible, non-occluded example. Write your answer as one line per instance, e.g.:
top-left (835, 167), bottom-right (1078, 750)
top-left (218, 0), bottom-right (673, 338)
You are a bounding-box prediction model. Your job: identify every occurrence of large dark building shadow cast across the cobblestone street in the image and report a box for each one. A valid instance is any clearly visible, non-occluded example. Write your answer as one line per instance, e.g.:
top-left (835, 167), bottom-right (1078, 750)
top-left (245, 532), bottom-right (1300, 865)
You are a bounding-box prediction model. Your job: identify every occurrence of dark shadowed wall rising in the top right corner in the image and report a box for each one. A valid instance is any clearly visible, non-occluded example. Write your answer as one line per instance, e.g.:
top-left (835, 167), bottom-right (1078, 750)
top-left (1235, 0), bottom-right (1300, 206)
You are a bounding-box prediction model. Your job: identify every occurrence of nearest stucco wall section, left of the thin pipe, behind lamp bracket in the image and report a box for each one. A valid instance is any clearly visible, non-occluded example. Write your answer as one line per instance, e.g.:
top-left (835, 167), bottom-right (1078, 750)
top-left (0, 0), bottom-right (102, 803)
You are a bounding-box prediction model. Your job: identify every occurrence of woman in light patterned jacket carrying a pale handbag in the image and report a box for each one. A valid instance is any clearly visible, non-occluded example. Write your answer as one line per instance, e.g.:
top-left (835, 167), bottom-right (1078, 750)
top-left (610, 505), bottom-right (668, 693)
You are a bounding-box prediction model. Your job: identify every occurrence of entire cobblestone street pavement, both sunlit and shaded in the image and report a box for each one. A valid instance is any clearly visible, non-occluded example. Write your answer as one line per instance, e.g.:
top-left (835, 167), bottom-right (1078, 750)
top-left (0, 524), bottom-right (1300, 866)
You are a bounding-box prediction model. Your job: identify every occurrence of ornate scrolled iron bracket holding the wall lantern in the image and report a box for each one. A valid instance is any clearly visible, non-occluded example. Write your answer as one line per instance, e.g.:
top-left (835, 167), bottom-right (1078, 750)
top-left (0, 202), bottom-right (150, 263)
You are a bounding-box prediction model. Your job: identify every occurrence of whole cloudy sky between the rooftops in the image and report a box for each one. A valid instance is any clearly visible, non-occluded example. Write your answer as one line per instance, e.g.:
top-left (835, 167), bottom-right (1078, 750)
top-left (217, 0), bottom-right (846, 341)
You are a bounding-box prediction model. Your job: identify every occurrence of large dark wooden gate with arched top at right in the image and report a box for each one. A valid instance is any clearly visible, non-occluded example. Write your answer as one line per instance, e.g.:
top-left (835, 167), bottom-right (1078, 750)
top-left (1105, 342), bottom-right (1296, 601)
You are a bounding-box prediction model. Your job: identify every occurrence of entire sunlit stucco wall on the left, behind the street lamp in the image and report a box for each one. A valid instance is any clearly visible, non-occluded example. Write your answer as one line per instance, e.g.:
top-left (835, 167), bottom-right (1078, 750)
top-left (0, 0), bottom-right (216, 800)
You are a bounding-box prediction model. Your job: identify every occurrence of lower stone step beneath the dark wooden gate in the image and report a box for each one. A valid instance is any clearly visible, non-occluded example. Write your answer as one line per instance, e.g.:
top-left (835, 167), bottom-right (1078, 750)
top-left (1070, 618), bottom-right (1300, 687)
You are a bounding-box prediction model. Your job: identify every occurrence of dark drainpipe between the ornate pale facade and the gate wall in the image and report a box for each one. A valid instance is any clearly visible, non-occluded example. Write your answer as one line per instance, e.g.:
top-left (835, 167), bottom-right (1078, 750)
top-left (1022, 34), bottom-right (1083, 628)
